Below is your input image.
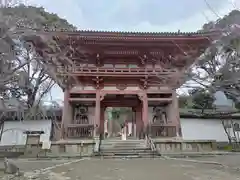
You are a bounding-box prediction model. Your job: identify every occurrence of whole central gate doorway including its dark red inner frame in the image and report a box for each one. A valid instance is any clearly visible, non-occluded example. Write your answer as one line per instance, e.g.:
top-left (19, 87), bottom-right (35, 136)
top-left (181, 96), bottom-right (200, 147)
top-left (100, 94), bottom-right (143, 140)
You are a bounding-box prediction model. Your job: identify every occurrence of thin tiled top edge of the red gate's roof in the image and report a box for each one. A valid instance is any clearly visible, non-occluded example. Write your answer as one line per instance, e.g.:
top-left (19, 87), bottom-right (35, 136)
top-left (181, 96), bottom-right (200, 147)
top-left (32, 30), bottom-right (220, 41)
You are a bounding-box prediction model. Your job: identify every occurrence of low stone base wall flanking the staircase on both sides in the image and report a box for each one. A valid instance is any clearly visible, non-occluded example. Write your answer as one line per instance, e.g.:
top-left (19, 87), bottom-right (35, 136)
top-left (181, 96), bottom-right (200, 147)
top-left (0, 139), bottom-right (217, 158)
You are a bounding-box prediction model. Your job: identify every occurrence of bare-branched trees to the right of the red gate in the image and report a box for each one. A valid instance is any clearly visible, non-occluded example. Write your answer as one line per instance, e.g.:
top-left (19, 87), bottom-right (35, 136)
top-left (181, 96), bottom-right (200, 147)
top-left (185, 8), bottom-right (240, 146)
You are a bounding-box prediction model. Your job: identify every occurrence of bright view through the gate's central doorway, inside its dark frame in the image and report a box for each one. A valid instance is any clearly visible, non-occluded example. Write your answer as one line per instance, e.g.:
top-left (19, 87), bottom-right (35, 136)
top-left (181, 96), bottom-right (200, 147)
top-left (104, 107), bottom-right (137, 140)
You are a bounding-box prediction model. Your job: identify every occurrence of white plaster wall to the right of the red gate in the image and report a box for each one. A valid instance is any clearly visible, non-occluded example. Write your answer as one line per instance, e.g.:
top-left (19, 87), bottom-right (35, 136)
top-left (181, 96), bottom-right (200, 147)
top-left (180, 118), bottom-right (240, 142)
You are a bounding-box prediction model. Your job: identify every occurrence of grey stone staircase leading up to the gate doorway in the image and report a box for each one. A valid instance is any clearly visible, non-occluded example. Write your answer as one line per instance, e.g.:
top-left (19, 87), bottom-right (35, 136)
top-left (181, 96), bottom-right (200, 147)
top-left (95, 139), bottom-right (157, 158)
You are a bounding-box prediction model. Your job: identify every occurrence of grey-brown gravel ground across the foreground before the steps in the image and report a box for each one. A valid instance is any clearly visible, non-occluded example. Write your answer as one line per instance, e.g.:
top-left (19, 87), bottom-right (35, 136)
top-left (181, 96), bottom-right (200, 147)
top-left (0, 156), bottom-right (240, 180)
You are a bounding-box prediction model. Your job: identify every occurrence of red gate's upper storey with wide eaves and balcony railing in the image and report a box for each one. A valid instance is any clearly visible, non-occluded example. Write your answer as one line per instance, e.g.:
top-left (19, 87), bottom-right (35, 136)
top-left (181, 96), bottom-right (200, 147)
top-left (23, 30), bottom-right (219, 88)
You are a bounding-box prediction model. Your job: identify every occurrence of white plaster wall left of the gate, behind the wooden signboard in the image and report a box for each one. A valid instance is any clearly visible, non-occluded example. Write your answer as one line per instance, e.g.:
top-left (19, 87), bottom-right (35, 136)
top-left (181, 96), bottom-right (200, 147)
top-left (0, 120), bottom-right (52, 145)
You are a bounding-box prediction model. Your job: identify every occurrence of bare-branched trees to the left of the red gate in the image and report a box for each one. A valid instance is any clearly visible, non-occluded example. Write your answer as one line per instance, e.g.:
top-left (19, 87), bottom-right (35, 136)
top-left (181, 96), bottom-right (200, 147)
top-left (0, 1), bottom-right (75, 128)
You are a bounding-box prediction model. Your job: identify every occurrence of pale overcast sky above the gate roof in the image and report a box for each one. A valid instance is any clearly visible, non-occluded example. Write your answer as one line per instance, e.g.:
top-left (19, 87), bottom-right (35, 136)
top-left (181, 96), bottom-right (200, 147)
top-left (26, 0), bottom-right (240, 99)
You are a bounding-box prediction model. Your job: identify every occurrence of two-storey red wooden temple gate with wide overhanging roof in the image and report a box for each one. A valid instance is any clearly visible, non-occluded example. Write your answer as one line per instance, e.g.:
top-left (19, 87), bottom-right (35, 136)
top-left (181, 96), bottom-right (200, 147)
top-left (24, 31), bottom-right (219, 138)
